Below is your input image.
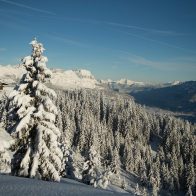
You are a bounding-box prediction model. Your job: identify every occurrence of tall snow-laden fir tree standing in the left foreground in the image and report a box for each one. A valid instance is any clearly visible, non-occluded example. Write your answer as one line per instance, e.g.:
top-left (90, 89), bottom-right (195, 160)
top-left (9, 39), bottom-right (63, 181)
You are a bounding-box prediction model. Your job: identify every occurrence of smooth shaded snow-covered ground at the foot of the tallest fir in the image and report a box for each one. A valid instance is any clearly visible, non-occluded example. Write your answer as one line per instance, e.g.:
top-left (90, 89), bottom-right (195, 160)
top-left (0, 175), bottom-right (130, 196)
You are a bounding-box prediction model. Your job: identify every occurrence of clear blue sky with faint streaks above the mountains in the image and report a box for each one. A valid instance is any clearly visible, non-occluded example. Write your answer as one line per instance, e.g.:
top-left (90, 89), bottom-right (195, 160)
top-left (0, 0), bottom-right (196, 82)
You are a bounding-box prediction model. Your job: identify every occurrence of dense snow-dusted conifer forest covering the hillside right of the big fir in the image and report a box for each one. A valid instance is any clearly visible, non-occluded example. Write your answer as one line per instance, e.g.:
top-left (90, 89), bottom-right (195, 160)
top-left (0, 90), bottom-right (196, 194)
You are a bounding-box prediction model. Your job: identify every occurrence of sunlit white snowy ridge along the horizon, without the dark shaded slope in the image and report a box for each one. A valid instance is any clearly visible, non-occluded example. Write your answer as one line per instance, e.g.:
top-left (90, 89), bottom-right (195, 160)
top-left (0, 65), bottom-right (182, 90)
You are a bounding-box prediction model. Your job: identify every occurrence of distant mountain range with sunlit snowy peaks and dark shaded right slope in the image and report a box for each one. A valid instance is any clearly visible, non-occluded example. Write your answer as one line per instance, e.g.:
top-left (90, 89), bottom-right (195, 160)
top-left (0, 65), bottom-right (196, 122)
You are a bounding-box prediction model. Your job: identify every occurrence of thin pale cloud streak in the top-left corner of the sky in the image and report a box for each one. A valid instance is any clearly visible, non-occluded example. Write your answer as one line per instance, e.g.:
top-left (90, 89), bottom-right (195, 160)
top-left (0, 0), bottom-right (55, 15)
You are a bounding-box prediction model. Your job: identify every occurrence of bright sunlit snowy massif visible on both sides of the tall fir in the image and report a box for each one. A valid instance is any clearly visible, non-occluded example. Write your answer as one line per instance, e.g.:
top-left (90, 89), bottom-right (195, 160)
top-left (0, 65), bottom-right (98, 89)
